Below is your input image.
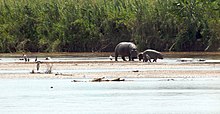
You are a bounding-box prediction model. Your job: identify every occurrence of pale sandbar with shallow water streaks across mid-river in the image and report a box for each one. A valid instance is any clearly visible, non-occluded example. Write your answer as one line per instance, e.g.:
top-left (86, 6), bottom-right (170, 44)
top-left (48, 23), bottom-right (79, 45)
top-left (0, 61), bottom-right (220, 79)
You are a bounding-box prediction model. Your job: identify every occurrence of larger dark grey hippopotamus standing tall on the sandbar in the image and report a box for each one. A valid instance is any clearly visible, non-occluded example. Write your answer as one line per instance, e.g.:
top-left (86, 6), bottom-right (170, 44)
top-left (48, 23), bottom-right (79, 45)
top-left (115, 42), bottom-right (138, 61)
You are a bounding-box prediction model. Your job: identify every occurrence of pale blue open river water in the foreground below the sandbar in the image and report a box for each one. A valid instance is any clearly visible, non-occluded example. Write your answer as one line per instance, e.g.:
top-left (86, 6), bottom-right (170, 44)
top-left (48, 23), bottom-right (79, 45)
top-left (0, 78), bottom-right (220, 114)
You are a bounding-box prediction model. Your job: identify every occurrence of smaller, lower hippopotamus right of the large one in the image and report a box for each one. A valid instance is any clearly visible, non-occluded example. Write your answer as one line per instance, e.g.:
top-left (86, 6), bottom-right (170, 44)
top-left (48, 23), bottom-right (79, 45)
top-left (138, 49), bottom-right (163, 62)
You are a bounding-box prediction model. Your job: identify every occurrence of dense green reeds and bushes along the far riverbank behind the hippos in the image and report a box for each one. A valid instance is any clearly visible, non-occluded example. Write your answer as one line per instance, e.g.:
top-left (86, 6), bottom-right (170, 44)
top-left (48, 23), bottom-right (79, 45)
top-left (0, 0), bottom-right (220, 52)
